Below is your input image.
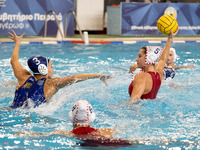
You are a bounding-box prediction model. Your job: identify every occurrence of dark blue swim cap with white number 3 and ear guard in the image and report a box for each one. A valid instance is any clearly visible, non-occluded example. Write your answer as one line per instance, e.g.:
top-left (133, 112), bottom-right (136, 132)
top-left (27, 56), bottom-right (48, 75)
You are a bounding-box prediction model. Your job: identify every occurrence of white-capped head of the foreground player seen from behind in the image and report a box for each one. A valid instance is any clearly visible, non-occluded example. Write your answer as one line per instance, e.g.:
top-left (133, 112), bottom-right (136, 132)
top-left (69, 100), bottom-right (95, 126)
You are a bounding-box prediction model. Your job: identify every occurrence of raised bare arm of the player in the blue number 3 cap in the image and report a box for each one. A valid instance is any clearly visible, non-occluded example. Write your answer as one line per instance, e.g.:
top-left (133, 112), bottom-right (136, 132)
top-left (9, 30), bottom-right (31, 84)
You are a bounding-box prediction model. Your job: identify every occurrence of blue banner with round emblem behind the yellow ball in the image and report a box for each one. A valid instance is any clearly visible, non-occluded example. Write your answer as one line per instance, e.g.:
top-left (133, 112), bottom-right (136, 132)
top-left (120, 3), bottom-right (200, 35)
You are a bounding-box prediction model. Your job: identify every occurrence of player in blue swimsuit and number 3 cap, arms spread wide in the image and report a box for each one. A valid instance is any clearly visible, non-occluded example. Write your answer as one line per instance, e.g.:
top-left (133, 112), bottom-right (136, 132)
top-left (9, 30), bottom-right (111, 109)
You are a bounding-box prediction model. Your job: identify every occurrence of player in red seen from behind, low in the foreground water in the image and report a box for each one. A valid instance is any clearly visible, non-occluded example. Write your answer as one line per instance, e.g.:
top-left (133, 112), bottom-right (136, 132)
top-left (15, 100), bottom-right (131, 146)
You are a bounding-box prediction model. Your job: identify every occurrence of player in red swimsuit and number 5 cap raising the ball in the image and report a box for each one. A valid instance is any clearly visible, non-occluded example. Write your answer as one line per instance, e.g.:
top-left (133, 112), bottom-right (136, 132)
top-left (129, 30), bottom-right (178, 101)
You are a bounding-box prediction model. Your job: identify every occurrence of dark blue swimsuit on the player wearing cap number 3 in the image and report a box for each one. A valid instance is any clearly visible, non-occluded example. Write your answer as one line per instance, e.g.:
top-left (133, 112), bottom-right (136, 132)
top-left (10, 76), bottom-right (46, 109)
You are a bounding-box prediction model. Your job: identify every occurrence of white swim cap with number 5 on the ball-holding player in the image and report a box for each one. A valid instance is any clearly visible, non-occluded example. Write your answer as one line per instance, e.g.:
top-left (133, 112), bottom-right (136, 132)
top-left (145, 46), bottom-right (163, 65)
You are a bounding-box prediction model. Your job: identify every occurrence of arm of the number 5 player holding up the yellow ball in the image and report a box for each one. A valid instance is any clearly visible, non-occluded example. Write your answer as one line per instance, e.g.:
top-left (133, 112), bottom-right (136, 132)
top-left (156, 29), bottom-right (178, 79)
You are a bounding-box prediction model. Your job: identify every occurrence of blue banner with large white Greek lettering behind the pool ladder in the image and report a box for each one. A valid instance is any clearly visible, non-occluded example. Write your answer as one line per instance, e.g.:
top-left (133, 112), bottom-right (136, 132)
top-left (0, 0), bottom-right (74, 36)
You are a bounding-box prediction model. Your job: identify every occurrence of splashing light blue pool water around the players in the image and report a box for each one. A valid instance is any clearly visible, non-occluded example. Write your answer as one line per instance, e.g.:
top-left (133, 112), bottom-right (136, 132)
top-left (0, 43), bottom-right (200, 150)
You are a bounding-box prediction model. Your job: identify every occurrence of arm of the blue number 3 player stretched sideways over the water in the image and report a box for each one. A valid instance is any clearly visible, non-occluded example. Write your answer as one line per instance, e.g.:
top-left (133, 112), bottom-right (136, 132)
top-left (53, 73), bottom-right (112, 88)
